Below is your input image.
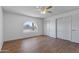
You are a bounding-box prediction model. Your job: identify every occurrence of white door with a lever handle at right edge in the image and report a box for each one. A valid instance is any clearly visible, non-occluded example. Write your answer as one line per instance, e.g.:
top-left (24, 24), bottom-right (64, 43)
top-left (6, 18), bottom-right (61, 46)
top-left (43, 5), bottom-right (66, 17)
top-left (72, 14), bottom-right (79, 43)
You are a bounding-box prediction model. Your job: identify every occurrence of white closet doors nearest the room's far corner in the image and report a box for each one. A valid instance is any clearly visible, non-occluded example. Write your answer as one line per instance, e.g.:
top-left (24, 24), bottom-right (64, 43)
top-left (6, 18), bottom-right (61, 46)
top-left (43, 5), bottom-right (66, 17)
top-left (44, 18), bottom-right (56, 38)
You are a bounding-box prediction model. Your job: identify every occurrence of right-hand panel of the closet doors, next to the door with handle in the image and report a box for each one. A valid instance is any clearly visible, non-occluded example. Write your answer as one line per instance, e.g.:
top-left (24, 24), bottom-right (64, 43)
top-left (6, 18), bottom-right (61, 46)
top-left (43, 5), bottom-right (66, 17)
top-left (63, 16), bottom-right (71, 40)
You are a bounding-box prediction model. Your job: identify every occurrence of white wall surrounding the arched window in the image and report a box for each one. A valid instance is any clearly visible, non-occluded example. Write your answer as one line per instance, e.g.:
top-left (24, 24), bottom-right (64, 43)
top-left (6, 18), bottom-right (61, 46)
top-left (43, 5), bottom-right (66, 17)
top-left (4, 12), bottom-right (43, 41)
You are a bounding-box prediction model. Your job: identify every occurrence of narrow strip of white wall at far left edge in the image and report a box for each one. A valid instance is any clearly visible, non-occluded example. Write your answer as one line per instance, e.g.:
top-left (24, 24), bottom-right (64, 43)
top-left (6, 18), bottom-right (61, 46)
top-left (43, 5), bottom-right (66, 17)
top-left (0, 6), bottom-right (3, 50)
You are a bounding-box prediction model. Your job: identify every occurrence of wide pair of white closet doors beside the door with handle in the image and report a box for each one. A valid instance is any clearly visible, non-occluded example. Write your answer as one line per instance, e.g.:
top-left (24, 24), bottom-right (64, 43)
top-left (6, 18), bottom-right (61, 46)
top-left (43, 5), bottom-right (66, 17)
top-left (57, 16), bottom-right (71, 40)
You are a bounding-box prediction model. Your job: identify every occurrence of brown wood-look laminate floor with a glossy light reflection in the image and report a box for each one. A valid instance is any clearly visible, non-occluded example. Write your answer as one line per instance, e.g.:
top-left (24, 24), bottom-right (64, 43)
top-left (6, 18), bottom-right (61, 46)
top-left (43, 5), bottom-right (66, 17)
top-left (2, 36), bottom-right (79, 53)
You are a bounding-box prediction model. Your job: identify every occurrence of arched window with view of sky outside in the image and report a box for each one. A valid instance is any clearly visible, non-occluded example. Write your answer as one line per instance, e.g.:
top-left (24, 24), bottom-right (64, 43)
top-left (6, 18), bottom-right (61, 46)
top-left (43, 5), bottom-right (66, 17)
top-left (23, 21), bottom-right (38, 32)
